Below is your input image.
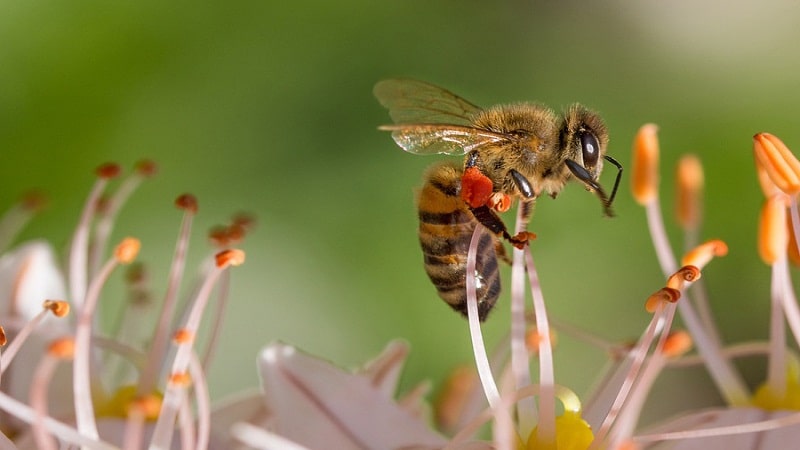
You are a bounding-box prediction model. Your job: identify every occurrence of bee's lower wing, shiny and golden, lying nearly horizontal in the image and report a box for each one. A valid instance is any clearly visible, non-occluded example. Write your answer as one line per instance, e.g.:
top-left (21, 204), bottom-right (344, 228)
top-left (380, 124), bottom-right (508, 155)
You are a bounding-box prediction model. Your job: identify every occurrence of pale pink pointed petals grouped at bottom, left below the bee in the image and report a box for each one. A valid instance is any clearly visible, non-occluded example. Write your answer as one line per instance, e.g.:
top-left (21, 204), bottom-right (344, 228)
top-left (209, 341), bottom-right (446, 449)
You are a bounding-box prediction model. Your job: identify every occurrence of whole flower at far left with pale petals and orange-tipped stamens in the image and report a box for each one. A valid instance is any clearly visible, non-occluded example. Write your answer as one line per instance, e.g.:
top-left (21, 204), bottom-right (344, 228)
top-left (0, 161), bottom-right (252, 449)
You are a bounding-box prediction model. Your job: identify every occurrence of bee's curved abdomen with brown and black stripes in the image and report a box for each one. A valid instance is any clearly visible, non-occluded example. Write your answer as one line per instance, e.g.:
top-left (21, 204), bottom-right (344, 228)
top-left (418, 163), bottom-right (500, 320)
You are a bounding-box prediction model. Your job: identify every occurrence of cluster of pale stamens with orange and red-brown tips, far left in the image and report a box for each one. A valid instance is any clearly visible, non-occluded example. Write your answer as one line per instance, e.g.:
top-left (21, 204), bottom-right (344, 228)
top-left (0, 161), bottom-right (248, 449)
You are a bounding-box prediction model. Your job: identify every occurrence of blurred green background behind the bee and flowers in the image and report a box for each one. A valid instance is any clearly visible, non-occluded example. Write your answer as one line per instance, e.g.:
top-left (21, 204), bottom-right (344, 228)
top-left (0, 0), bottom-right (800, 426)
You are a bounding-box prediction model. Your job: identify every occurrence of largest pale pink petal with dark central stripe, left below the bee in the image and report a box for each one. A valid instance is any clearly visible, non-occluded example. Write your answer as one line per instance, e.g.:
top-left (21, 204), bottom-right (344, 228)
top-left (259, 343), bottom-right (446, 449)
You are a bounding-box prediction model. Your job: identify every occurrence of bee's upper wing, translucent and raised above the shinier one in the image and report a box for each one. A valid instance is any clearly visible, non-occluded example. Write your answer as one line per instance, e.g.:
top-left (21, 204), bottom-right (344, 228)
top-left (373, 79), bottom-right (481, 126)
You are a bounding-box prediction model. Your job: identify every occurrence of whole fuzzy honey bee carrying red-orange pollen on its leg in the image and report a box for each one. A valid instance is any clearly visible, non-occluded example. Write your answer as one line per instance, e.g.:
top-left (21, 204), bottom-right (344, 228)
top-left (374, 79), bottom-right (622, 321)
